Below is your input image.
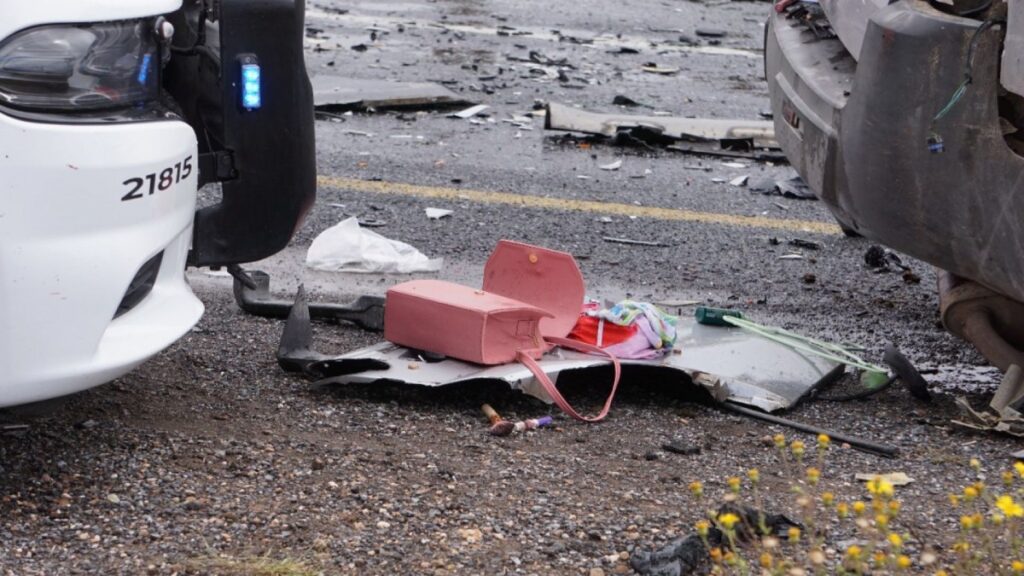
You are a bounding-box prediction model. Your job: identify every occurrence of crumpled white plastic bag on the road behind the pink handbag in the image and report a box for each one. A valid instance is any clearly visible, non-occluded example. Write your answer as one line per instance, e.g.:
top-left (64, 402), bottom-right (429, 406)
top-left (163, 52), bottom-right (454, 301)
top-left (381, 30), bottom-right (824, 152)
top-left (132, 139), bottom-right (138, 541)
top-left (306, 217), bottom-right (444, 274)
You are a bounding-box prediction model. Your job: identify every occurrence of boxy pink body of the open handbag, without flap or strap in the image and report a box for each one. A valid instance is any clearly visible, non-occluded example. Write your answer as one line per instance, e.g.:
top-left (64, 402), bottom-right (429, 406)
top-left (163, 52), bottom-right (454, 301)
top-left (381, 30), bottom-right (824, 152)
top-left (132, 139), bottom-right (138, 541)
top-left (384, 280), bottom-right (552, 365)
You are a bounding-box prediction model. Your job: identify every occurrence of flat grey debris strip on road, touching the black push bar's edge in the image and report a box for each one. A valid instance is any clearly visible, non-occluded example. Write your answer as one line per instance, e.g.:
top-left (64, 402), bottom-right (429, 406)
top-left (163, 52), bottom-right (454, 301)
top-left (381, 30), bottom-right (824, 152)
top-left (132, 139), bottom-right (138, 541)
top-left (311, 76), bottom-right (473, 113)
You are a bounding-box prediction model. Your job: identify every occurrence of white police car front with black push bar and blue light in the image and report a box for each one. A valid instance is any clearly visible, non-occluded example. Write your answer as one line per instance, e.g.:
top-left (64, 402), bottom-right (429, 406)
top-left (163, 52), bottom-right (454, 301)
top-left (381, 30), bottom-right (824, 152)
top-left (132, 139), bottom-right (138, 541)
top-left (0, 0), bottom-right (315, 407)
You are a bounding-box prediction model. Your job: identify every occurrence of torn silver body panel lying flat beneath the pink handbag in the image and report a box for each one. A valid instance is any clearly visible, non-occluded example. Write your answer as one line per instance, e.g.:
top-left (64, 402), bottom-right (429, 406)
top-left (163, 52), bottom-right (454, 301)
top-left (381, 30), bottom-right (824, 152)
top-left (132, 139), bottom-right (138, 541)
top-left (301, 319), bottom-right (845, 412)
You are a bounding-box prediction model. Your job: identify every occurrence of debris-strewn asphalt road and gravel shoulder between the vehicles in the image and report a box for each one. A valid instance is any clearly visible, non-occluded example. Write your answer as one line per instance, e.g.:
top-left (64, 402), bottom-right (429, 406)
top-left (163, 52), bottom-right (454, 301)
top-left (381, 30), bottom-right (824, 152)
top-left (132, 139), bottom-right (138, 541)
top-left (0, 0), bottom-right (1013, 575)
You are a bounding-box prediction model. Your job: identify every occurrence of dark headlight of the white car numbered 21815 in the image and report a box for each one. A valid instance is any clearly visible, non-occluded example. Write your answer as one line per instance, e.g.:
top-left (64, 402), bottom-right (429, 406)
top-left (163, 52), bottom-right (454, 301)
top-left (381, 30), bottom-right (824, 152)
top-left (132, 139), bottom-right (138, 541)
top-left (0, 18), bottom-right (161, 113)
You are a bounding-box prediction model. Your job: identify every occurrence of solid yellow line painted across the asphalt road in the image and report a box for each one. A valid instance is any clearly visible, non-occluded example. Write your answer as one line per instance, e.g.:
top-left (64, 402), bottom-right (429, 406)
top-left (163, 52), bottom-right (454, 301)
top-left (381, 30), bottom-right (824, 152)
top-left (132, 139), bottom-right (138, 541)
top-left (317, 175), bottom-right (842, 235)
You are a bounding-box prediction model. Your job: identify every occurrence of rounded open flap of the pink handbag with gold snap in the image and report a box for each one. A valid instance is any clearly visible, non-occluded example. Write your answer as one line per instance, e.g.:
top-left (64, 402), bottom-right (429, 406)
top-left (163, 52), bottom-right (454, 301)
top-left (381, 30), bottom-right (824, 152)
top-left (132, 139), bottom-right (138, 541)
top-left (483, 240), bottom-right (586, 338)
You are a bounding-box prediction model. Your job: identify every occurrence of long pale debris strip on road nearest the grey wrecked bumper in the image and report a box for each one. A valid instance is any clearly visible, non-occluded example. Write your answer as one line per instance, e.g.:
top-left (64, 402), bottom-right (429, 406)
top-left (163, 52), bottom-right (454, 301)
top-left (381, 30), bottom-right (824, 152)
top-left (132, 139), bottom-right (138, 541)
top-left (545, 102), bottom-right (778, 149)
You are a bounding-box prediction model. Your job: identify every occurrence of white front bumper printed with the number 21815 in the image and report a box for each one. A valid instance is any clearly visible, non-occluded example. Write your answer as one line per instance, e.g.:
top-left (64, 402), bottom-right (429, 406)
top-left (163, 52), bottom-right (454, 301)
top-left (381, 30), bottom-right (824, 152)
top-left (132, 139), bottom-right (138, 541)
top-left (0, 114), bottom-right (203, 407)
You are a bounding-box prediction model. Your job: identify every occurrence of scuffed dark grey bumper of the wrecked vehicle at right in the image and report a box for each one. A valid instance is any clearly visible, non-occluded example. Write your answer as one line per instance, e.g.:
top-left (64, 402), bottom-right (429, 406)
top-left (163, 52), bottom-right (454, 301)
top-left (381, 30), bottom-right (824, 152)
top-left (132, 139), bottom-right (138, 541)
top-left (765, 0), bottom-right (1024, 301)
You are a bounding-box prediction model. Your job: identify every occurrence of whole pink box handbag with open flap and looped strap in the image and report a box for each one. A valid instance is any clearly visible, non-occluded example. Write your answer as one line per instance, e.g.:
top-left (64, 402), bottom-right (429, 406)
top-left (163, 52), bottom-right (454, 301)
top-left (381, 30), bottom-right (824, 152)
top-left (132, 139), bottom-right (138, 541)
top-left (384, 240), bottom-right (622, 422)
